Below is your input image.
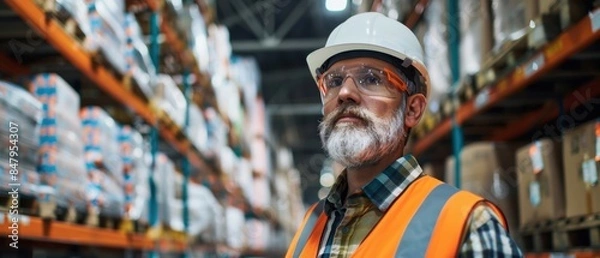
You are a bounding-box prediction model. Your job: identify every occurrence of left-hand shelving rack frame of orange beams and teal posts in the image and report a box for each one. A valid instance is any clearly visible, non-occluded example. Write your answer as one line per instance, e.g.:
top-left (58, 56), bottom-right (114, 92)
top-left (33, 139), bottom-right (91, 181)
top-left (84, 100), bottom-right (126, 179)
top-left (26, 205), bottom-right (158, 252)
top-left (0, 0), bottom-right (220, 256)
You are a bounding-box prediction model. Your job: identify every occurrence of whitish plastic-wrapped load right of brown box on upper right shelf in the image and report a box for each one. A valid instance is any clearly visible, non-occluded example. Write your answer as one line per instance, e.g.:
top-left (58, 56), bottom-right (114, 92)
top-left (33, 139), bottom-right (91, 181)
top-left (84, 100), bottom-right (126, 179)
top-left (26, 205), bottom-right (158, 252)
top-left (492, 0), bottom-right (529, 49)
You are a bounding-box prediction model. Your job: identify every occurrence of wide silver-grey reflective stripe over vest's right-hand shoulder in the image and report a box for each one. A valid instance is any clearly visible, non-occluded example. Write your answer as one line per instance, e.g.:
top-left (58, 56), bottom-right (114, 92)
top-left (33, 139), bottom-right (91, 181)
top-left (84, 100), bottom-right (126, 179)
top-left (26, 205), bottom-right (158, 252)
top-left (395, 184), bottom-right (460, 257)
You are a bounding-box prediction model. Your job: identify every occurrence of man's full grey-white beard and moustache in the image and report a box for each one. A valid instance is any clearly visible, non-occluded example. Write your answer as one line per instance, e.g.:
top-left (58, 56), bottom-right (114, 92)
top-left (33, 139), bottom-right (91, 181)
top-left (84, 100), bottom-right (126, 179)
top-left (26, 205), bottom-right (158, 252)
top-left (319, 106), bottom-right (404, 168)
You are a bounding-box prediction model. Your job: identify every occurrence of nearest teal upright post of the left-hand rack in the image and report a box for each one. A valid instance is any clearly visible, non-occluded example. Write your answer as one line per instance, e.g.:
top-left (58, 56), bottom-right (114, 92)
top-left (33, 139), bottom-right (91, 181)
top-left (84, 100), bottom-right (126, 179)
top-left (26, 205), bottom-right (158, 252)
top-left (148, 11), bottom-right (160, 258)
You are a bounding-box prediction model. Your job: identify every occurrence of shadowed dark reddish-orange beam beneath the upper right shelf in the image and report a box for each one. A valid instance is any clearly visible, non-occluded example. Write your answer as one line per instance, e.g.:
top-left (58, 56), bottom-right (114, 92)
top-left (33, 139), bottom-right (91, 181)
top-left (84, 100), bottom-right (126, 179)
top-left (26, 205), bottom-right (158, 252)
top-left (488, 78), bottom-right (600, 141)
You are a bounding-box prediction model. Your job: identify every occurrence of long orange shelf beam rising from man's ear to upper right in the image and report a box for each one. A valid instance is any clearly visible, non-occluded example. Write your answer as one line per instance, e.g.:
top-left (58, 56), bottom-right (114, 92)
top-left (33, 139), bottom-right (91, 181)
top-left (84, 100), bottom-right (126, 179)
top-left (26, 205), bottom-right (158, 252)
top-left (413, 9), bottom-right (600, 155)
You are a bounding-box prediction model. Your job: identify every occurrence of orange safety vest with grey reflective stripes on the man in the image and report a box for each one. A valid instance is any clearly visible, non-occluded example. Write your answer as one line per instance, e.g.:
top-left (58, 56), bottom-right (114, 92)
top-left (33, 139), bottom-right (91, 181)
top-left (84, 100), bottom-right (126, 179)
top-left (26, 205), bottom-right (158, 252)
top-left (286, 176), bottom-right (508, 258)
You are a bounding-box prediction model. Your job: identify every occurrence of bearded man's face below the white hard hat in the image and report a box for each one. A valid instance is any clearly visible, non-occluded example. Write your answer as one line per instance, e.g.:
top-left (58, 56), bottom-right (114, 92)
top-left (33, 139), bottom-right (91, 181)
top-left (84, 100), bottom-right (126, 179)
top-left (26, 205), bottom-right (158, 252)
top-left (319, 58), bottom-right (406, 167)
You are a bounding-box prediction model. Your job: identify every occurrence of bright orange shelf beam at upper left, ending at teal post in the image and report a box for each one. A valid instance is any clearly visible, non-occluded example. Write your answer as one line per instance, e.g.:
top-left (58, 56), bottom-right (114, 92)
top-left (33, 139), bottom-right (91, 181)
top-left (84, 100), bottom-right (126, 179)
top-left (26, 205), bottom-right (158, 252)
top-left (5, 0), bottom-right (156, 124)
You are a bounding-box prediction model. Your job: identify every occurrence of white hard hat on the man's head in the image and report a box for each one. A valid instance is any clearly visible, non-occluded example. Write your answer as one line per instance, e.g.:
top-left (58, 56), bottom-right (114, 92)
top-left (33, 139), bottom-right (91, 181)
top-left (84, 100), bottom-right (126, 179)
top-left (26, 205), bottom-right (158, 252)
top-left (306, 12), bottom-right (431, 96)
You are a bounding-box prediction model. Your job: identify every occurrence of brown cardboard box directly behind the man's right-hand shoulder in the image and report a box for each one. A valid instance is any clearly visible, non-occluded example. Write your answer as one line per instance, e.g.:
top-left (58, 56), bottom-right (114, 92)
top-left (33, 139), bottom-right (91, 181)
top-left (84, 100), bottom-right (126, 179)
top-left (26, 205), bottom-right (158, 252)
top-left (446, 142), bottom-right (519, 239)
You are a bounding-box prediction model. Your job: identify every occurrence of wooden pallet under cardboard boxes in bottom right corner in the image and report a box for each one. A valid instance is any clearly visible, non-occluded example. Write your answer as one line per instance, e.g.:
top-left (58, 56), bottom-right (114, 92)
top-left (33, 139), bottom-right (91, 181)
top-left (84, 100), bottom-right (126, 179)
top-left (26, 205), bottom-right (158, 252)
top-left (520, 213), bottom-right (600, 252)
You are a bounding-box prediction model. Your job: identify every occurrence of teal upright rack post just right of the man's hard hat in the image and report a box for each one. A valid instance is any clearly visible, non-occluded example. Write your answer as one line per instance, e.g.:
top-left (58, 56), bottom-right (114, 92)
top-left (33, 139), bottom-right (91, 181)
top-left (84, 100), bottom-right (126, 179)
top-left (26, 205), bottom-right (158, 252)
top-left (447, 0), bottom-right (464, 188)
